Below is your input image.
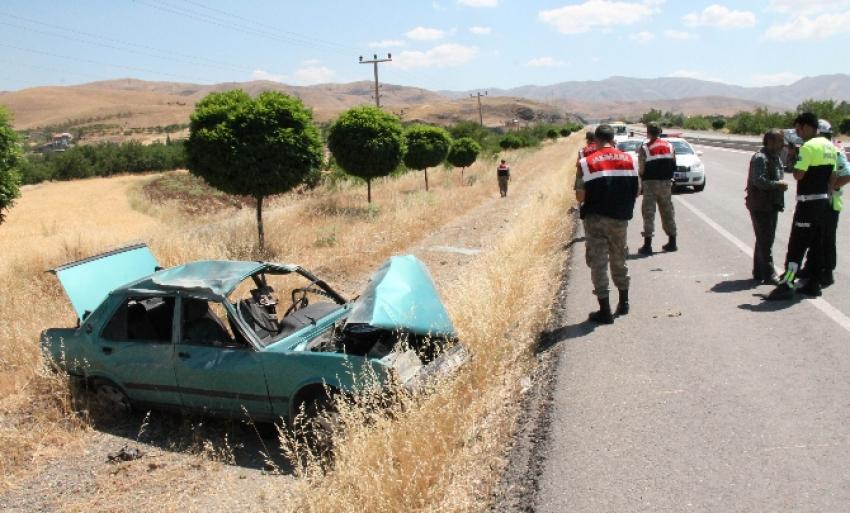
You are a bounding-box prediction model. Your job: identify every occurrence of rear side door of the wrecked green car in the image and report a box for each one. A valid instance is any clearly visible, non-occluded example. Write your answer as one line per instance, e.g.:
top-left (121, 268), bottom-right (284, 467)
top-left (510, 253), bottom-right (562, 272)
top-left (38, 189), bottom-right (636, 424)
top-left (95, 296), bottom-right (181, 406)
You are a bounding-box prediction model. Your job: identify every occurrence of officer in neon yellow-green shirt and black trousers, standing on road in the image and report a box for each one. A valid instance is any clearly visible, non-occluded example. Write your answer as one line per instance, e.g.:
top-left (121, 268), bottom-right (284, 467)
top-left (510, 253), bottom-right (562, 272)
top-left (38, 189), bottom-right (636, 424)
top-left (767, 112), bottom-right (838, 300)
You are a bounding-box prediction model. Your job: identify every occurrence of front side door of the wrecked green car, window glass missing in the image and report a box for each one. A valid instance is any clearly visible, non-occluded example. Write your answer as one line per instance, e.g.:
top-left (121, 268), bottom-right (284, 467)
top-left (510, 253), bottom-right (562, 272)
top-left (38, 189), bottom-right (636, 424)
top-left (174, 297), bottom-right (272, 420)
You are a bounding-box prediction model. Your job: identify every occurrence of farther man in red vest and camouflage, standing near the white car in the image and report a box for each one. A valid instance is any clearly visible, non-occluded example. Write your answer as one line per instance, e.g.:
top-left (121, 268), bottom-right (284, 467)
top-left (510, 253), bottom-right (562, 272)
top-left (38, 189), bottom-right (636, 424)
top-left (638, 121), bottom-right (679, 255)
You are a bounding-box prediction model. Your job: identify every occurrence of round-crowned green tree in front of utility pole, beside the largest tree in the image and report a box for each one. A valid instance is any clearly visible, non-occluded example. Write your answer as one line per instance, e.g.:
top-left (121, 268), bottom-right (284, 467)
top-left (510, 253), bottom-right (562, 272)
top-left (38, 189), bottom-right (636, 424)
top-left (328, 106), bottom-right (404, 203)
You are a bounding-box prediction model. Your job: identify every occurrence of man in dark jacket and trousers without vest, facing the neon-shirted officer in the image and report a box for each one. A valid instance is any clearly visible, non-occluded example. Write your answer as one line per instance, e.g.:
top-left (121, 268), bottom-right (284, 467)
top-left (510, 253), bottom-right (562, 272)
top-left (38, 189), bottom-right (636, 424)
top-left (745, 129), bottom-right (788, 285)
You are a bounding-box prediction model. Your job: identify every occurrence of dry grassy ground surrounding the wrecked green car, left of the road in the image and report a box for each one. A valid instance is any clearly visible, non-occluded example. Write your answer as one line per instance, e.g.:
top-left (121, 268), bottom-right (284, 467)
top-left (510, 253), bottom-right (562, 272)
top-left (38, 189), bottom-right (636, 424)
top-left (0, 136), bottom-right (579, 512)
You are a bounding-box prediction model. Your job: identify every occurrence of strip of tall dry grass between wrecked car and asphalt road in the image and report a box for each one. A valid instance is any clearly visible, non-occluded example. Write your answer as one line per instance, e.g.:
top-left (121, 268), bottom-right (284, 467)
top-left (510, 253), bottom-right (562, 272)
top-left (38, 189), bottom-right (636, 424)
top-left (280, 136), bottom-right (577, 513)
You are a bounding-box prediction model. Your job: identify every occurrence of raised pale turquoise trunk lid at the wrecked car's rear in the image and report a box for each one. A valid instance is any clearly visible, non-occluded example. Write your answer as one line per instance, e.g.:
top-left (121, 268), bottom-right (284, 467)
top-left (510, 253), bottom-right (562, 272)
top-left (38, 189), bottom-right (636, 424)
top-left (50, 244), bottom-right (158, 320)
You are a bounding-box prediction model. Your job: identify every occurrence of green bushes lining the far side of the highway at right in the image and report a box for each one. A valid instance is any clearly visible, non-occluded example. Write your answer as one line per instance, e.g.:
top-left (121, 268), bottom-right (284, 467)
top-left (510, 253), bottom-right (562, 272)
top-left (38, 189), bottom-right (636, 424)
top-left (640, 100), bottom-right (850, 135)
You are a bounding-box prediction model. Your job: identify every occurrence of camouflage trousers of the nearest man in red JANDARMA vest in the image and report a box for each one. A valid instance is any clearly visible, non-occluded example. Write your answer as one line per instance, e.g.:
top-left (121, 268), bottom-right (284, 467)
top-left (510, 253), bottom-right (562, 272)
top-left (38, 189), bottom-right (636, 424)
top-left (584, 214), bottom-right (629, 298)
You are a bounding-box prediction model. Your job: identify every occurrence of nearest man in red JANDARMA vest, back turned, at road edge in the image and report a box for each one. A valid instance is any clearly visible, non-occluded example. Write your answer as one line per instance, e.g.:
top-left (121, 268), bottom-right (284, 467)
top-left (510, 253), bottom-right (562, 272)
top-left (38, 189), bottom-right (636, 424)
top-left (575, 125), bottom-right (639, 324)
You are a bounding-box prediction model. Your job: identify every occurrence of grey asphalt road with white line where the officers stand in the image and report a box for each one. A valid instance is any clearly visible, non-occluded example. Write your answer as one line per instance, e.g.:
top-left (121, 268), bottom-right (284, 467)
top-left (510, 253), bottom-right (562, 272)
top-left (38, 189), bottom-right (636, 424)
top-left (535, 148), bottom-right (850, 513)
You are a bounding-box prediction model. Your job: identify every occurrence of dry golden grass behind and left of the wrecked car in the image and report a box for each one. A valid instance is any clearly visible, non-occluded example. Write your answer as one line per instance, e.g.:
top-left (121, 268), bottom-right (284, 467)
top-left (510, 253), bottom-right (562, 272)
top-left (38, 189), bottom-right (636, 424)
top-left (0, 140), bottom-right (563, 489)
